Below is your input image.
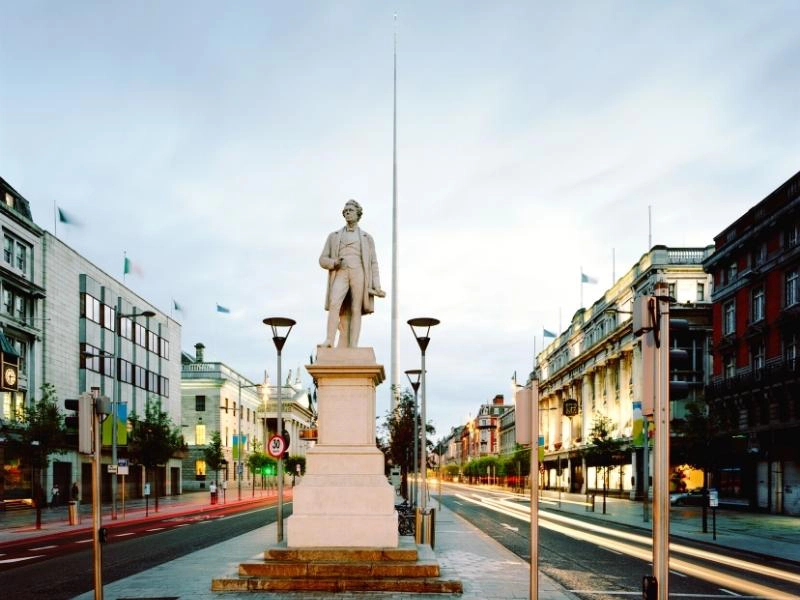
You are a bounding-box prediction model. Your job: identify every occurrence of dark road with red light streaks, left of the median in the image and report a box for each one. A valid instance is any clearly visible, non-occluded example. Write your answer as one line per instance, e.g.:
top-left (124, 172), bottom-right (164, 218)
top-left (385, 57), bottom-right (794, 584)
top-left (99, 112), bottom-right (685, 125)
top-left (0, 503), bottom-right (291, 600)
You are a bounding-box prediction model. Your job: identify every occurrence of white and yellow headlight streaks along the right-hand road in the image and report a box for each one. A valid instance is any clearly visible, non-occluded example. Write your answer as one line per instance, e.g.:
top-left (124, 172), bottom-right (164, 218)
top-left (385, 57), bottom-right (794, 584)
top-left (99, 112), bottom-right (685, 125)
top-left (455, 493), bottom-right (800, 600)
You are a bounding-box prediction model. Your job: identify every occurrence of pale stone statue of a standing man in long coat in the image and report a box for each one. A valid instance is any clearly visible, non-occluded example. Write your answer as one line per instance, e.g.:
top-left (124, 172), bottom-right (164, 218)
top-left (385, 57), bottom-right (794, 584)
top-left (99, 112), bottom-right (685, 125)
top-left (319, 200), bottom-right (386, 348)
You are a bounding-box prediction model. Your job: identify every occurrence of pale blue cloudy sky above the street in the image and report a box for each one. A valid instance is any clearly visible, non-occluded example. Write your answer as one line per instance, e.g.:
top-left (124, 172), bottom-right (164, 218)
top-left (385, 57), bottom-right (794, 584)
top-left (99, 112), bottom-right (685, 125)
top-left (0, 0), bottom-right (800, 438)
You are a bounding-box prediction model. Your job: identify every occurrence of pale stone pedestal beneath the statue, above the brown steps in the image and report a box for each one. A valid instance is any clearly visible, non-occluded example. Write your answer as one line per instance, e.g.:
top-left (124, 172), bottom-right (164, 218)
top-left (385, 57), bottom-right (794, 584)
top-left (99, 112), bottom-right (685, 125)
top-left (286, 348), bottom-right (398, 548)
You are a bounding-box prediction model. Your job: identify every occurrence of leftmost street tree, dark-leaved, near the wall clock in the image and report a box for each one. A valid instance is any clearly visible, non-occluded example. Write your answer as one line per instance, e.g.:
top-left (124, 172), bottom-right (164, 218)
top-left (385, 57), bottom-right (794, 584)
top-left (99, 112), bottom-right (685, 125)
top-left (0, 383), bottom-right (70, 529)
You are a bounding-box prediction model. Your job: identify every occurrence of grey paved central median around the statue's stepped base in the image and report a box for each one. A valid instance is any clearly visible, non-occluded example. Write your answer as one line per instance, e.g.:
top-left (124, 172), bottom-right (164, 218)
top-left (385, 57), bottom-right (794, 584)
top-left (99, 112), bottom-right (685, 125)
top-left (77, 501), bottom-right (577, 600)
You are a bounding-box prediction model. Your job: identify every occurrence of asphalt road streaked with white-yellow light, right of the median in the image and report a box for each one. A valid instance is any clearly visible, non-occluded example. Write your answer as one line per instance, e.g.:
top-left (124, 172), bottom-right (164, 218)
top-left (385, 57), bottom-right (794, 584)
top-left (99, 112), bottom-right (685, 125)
top-left (433, 484), bottom-right (800, 600)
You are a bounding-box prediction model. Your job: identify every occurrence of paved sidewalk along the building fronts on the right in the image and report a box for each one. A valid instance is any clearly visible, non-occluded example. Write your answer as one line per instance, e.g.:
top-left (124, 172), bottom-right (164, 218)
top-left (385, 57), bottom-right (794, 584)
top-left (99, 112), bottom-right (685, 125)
top-left (539, 490), bottom-right (800, 565)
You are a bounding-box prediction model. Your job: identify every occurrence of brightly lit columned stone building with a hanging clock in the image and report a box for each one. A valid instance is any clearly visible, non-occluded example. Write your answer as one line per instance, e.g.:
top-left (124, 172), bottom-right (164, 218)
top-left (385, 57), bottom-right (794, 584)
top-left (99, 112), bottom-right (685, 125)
top-left (535, 246), bottom-right (713, 497)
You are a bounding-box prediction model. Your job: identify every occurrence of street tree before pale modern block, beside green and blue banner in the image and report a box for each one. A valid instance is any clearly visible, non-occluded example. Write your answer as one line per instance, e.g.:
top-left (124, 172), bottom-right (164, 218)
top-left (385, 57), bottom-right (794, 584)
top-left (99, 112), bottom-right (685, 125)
top-left (128, 402), bottom-right (187, 512)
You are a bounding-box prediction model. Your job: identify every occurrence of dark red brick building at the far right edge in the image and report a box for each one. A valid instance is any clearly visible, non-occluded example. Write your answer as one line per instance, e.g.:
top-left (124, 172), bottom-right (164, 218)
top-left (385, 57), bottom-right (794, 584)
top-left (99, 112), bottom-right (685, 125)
top-left (705, 173), bottom-right (800, 515)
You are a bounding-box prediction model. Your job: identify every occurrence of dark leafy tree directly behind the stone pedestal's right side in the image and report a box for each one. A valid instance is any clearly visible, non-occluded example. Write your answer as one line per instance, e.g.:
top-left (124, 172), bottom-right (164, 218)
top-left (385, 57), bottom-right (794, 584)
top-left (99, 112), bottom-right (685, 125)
top-left (379, 389), bottom-right (436, 497)
